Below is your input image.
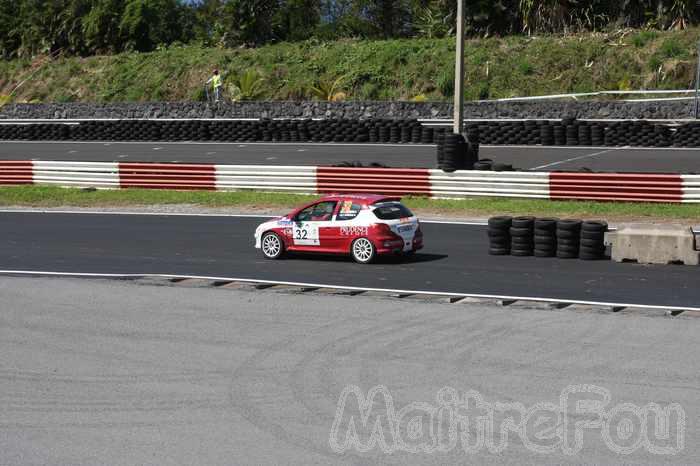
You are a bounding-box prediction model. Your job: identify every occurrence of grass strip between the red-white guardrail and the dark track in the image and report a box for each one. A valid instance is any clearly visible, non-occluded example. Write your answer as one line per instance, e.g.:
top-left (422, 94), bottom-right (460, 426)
top-left (5, 186), bottom-right (700, 223)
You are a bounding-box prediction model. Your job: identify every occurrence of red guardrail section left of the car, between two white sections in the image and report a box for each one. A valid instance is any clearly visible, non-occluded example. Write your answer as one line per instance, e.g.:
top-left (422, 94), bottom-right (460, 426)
top-left (119, 162), bottom-right (216, 190)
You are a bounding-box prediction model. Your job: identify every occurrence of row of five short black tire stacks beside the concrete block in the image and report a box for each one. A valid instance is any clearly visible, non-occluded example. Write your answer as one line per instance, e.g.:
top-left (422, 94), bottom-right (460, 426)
top-left (487, 216), bottom-right (608, 260)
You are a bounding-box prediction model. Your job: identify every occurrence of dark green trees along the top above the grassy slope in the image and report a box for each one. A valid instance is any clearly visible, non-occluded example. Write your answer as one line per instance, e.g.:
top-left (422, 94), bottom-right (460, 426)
top-left (5, 0), bottom-right (700, 58)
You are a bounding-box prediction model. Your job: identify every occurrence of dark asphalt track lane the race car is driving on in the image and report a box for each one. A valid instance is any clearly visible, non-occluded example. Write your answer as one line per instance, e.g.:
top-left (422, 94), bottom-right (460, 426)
top-left (0, 212), bottom-right (700, 307)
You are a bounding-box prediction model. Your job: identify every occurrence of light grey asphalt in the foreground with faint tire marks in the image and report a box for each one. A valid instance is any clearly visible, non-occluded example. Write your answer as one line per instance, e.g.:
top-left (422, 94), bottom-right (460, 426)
top-left (0, 277), bottom-right (700, 466)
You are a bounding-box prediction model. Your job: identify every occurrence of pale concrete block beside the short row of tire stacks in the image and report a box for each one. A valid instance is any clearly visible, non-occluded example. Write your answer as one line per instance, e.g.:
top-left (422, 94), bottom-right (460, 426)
top-left (606, 224), bottom-right (700, 265)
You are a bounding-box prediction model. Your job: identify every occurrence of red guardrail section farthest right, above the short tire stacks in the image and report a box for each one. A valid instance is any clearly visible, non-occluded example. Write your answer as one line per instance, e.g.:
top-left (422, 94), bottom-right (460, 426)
top-left (549, 173), bottom-right (683, 202)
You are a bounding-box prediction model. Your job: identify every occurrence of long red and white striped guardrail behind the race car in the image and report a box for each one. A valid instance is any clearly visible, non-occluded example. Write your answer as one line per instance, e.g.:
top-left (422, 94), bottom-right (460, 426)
top-left (0, 160), bottom-right (700, 203)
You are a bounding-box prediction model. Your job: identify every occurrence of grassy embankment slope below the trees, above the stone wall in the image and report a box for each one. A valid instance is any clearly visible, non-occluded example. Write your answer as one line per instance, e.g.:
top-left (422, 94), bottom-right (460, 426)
top-left (0, 27), bottom-right (700, 102)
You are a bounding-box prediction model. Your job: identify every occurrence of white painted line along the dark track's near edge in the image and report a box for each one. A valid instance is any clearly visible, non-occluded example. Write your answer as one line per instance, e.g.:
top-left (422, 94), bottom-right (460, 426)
top-left (0, 270), bottom-right (700, 311)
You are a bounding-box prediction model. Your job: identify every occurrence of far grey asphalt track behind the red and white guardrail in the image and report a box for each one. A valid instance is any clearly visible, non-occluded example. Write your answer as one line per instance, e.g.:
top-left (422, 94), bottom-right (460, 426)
top-left (0, 141), bottom-right (700, 173)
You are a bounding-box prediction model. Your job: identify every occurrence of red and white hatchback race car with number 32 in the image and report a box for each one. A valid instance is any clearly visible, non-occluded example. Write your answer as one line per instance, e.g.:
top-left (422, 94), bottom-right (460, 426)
top-left (255, 194), bottom-right (423, 264)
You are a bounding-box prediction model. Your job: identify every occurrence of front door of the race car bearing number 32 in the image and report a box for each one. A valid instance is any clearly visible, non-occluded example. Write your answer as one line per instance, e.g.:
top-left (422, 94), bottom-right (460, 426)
top-left (290, 201), bottom-right (337, 252)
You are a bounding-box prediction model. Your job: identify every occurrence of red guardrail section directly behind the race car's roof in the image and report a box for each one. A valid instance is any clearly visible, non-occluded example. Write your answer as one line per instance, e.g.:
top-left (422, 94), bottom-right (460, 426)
top-left (316, 167), bottom-right (430, 196)
